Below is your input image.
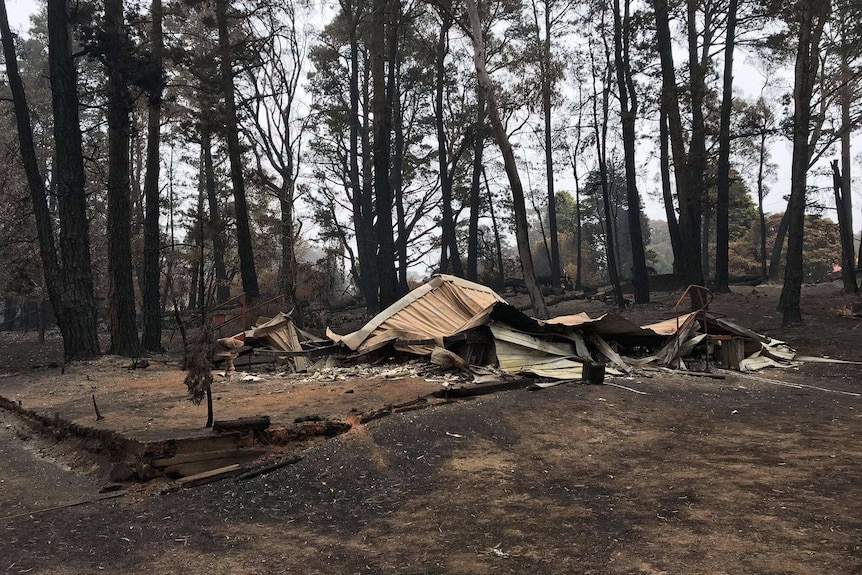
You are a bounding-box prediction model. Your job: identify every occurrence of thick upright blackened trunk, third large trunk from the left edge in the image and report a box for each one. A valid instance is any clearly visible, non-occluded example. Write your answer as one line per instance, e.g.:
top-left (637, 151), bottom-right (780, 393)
top-left (104, 0), bottom-right (141, 357)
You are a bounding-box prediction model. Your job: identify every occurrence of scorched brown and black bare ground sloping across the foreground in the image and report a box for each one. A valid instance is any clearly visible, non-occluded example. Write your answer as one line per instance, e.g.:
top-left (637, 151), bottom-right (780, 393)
top-left (0, 284), bottom-right (862, 574)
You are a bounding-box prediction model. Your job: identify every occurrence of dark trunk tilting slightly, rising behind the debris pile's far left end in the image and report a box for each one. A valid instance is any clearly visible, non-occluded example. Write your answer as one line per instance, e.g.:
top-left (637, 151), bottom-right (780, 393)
top-left (216, 0), bottom-right (260, 300)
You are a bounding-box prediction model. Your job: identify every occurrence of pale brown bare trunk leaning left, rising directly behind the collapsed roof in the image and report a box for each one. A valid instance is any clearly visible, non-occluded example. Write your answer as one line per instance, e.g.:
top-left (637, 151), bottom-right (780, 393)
top-left (464, 0), bottom-right (548, 319)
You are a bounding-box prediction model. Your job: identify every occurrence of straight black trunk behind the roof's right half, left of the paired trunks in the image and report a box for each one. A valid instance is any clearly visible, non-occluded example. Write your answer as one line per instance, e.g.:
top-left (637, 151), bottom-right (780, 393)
top-left (613, 0), bottom-right (649, 303)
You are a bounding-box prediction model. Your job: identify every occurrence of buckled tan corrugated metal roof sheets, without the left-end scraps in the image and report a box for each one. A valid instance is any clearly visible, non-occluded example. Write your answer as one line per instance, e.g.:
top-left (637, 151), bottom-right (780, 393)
top-left (327, 275), bottom-right (795, 380)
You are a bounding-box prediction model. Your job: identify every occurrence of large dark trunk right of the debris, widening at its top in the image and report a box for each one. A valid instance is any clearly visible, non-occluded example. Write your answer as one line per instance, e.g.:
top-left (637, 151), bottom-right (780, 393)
top-left (778, 0), bottom-right (832, 325)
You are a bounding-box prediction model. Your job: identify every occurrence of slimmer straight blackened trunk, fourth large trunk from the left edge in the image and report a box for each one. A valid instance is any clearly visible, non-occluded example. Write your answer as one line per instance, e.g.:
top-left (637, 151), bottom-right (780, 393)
top-left (140, 0), bottom-right (164, 352)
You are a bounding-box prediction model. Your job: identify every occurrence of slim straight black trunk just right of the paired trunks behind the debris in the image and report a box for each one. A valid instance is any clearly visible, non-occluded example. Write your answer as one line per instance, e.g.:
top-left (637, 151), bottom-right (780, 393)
top-left (713, 0), bottom-right (739, 293)
